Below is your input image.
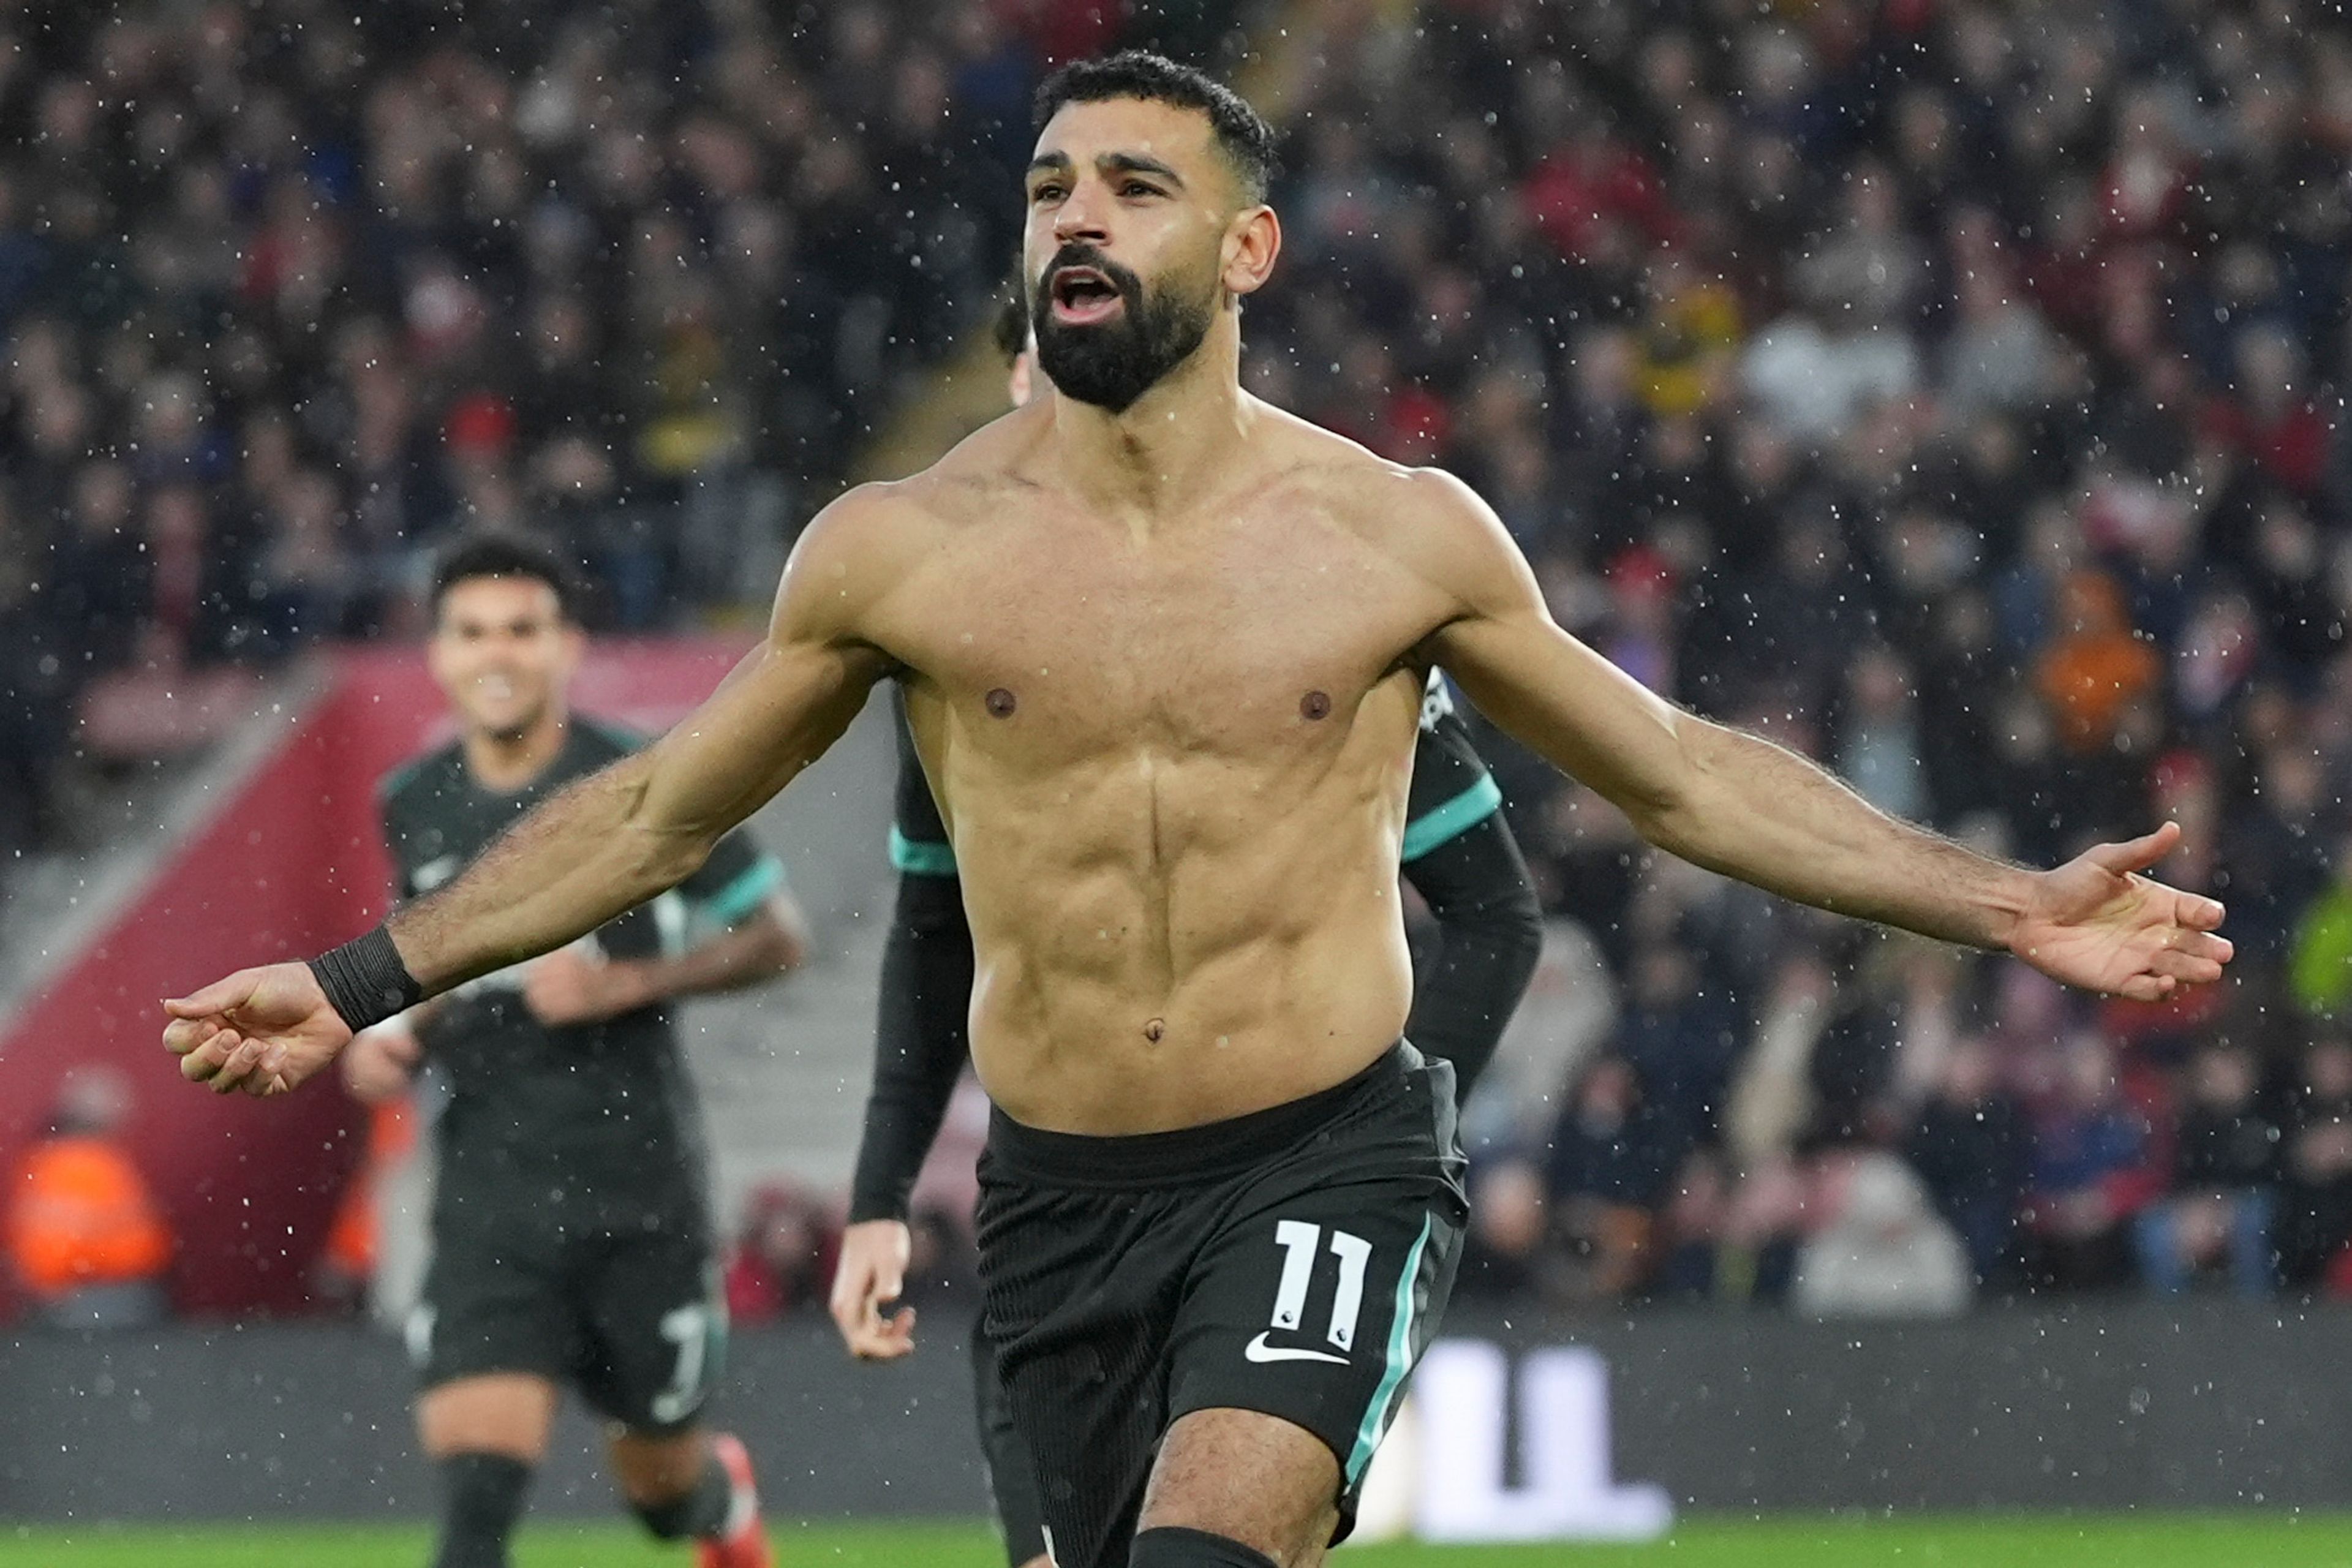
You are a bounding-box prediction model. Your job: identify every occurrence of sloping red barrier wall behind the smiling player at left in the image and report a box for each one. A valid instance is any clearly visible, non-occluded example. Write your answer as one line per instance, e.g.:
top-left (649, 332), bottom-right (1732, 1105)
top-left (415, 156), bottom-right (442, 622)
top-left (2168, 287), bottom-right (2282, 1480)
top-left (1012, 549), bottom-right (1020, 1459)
top-left (0, 637), bottom-right (745, 1314)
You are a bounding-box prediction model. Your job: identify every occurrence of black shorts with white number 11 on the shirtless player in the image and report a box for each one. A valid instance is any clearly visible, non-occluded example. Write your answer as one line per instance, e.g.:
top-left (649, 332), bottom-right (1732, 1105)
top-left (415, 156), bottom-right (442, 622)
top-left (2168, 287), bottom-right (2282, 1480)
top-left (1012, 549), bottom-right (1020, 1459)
top-left (981, 1041), bottom-right (1468, 1568)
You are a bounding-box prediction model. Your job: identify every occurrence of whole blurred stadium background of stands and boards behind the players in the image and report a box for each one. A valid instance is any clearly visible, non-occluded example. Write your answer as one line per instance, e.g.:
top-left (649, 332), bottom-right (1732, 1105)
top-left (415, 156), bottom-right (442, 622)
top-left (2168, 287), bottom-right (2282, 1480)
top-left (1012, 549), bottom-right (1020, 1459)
top-left (0, 0), bottom-right (2352, 1563)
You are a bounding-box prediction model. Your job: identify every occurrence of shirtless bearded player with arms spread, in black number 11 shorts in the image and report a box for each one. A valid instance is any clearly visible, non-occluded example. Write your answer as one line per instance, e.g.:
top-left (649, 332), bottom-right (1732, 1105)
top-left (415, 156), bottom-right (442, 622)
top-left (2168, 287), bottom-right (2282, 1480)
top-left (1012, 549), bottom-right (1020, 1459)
top-left (165, 54), bottom-right (2230, 1568)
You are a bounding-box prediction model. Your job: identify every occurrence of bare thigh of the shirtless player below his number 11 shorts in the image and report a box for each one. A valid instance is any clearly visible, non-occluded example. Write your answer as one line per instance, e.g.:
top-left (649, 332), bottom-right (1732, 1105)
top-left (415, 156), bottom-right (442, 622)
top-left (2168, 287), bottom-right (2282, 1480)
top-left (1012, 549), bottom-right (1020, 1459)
top-left (1136, 1408), bottom-right (1338, 1568)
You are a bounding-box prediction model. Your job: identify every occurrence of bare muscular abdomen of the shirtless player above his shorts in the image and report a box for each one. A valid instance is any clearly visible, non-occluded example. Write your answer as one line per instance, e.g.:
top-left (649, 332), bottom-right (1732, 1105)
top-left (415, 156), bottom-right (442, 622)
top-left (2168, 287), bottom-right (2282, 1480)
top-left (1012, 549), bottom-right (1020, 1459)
top-left (955, 745), bottom-right (1411, 1136)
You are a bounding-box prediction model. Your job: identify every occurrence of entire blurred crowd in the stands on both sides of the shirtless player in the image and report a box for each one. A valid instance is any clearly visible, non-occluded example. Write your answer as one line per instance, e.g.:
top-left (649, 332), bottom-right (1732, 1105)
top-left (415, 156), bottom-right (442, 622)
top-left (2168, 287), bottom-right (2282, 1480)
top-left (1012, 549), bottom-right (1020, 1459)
top-left (13, 0), bottom-right (2352, 1312)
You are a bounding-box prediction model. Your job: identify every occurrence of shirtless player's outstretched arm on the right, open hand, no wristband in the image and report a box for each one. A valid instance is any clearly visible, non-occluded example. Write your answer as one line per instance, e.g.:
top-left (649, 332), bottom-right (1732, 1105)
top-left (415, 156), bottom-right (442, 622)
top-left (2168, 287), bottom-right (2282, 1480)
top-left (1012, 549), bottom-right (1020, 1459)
top-left (1414, 472), bottom-right (2230, 999)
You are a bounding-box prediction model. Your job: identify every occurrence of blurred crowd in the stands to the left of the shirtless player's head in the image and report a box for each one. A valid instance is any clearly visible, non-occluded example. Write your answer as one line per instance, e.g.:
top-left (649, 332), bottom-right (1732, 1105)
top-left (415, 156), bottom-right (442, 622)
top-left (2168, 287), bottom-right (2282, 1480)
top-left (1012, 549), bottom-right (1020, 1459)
top-left (0, 0), bottom-right (1232, 884)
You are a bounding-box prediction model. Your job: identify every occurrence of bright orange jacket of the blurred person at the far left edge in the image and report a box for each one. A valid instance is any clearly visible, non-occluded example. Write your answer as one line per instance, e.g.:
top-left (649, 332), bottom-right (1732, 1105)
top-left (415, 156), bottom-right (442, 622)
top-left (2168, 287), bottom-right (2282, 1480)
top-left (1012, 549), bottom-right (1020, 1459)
top-left (5, 1136), bottom-right (172, 1300)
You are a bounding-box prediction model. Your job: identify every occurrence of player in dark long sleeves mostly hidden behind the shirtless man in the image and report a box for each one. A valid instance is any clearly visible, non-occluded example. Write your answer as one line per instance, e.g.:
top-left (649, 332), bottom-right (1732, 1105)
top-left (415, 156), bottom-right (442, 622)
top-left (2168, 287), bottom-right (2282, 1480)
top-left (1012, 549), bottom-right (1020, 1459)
top-left (832, 301), bottom-right (1543, 1568)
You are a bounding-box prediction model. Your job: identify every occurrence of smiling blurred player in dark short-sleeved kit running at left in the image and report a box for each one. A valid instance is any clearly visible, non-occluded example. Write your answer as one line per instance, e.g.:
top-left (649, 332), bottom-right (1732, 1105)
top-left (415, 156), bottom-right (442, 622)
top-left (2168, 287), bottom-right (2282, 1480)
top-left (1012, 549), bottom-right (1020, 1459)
top-left (344, 538), bottom-right (804, 1568)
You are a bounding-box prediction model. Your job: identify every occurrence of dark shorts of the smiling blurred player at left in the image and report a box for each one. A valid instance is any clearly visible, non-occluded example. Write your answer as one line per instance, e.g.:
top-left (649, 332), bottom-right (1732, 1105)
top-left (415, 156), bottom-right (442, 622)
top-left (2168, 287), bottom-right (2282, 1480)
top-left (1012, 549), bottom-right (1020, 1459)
top-left (407, 1223), bottom-right (727, 1436)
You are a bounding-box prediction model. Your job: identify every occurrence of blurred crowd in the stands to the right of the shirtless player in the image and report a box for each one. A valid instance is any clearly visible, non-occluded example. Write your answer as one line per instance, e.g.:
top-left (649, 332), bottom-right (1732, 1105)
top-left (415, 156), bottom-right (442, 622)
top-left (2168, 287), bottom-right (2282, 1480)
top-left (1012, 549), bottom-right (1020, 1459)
top-left (1249, 0), bottom-right (2352, 1312)
